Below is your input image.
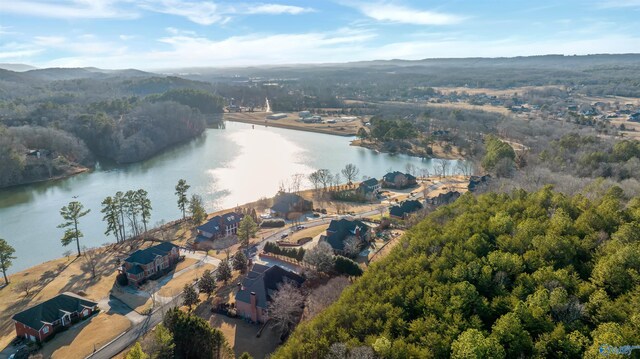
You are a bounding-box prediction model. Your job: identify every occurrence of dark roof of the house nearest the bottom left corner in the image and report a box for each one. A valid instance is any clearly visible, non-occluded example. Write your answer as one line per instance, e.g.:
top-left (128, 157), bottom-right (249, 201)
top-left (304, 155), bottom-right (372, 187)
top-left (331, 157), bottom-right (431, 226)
top-left (12, 293), bottom-right (98, 330)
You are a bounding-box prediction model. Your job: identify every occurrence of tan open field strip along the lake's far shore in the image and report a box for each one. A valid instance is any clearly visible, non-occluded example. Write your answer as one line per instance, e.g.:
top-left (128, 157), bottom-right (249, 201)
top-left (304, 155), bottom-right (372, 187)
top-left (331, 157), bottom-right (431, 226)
top-left (223, 112), bottom-right (362, 136)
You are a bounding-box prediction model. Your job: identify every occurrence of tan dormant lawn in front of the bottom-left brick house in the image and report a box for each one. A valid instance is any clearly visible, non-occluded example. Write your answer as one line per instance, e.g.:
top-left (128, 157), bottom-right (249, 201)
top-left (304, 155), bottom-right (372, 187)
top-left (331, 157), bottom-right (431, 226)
top-left (40, 313), bottom-right (131, 359)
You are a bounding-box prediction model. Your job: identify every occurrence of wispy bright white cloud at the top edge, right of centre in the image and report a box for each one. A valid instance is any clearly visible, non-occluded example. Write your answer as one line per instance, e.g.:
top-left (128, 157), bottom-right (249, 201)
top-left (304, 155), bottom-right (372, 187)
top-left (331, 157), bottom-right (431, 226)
top-left (345, 2), bottom-right (464, 25)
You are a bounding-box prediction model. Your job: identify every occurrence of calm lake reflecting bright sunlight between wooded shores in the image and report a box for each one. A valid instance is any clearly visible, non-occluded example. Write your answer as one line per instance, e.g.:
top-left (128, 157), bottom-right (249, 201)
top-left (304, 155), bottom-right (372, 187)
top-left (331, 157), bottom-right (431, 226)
top-left (0, 122), bottom-right (454, 273)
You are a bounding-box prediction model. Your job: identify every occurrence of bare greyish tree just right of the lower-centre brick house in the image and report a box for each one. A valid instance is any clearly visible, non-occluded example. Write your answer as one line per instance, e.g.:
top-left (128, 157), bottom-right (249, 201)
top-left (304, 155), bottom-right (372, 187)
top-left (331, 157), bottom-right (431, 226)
top-left (268, 281), bottom-right (304, 332)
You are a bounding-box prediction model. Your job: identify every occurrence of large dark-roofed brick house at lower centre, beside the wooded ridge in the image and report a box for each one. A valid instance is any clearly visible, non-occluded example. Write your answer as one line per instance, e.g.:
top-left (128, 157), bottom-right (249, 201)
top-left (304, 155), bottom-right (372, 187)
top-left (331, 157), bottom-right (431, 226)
top-left (236, 264), bottom-right (304, 323)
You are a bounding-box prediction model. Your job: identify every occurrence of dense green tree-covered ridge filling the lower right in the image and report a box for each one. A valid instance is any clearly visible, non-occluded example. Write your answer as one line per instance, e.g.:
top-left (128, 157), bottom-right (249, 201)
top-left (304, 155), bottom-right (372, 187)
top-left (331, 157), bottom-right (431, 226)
top-left (273, 187), bottom-right (640, 358)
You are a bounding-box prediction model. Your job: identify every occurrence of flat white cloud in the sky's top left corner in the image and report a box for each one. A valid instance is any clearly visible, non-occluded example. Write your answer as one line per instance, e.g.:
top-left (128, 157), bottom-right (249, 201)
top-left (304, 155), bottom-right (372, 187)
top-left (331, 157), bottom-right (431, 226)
top-left (0, 0), bottom-right (138, 19)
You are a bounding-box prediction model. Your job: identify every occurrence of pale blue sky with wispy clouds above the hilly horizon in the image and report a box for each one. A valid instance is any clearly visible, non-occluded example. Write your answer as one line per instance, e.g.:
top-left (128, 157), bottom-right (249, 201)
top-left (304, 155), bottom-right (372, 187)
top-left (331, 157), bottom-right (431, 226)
top-left (0, 0), bottom-right (640, 69)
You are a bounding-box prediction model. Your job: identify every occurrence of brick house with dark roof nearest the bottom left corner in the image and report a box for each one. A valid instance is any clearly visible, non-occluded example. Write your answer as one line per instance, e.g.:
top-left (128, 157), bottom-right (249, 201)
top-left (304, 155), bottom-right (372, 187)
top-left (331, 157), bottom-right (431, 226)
top-left (11, 292), bottom-right (98, 342)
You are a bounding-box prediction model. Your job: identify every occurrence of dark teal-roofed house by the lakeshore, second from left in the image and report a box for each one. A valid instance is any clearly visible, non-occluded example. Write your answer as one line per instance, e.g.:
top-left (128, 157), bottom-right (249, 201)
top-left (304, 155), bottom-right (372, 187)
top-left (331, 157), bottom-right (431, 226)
top-left (120, 242), bottom-right (180, 285)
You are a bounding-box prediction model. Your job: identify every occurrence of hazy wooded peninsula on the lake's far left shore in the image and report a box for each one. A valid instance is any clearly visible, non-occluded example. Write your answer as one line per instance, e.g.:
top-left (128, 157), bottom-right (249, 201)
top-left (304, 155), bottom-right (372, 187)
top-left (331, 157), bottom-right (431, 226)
top-left (0, 74), bottom-right (224, 187)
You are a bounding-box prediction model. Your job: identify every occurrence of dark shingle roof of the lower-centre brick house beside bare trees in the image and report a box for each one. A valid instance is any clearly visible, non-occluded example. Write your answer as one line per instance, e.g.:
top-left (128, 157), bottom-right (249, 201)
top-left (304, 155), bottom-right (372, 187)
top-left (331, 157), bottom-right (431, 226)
top-left (236, 264), bottom-right (304, 308)
